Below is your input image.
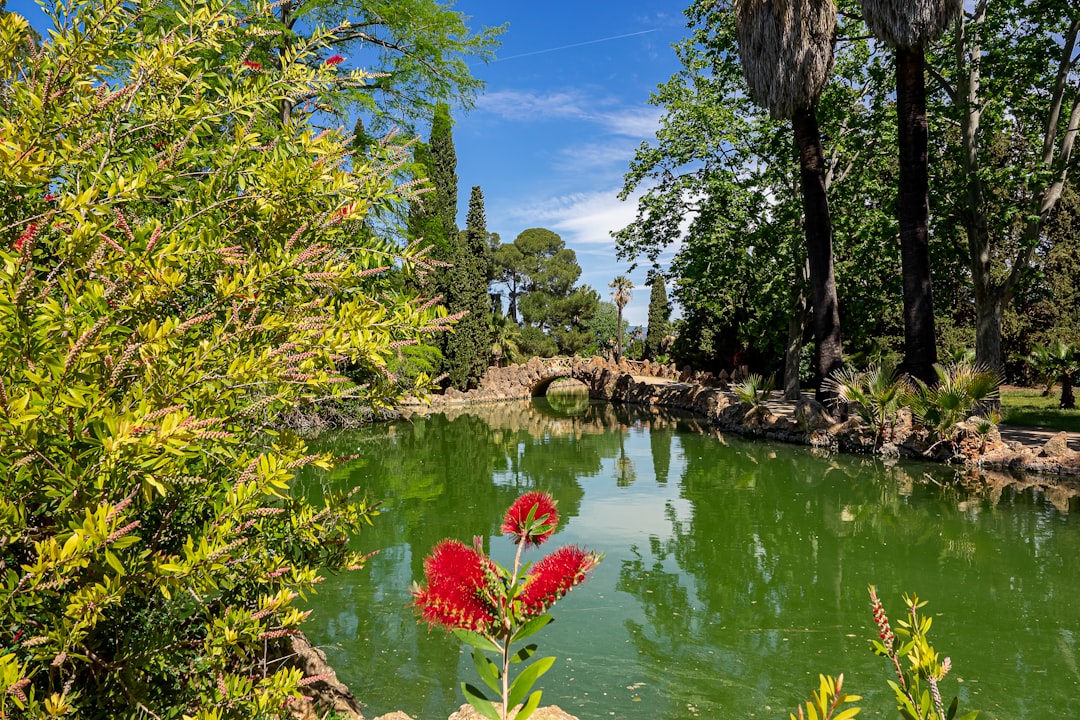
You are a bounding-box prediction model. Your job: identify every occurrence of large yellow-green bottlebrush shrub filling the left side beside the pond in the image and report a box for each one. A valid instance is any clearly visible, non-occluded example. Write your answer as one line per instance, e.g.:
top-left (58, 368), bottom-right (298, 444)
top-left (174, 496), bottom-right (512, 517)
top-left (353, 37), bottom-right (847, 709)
top-left (0, 0), bottom-right (445, 718)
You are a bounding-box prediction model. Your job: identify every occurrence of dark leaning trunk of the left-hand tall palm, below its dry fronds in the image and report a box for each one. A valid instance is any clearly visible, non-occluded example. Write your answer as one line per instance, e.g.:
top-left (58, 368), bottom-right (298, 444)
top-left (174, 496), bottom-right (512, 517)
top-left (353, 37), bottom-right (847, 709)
top-left (792, 108), bottom-right (843, 403)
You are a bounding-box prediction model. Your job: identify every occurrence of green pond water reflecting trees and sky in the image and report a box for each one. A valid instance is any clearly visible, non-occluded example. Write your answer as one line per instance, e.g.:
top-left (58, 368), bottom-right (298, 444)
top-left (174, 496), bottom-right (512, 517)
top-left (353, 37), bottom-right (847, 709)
top-left (298, 396), bottom-right (1080, 720)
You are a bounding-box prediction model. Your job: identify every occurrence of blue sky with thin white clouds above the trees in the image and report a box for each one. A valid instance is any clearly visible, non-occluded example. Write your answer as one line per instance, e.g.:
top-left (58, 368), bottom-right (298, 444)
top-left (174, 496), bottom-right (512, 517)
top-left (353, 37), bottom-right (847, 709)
top-left (8, 0), bottom-right (688, 325)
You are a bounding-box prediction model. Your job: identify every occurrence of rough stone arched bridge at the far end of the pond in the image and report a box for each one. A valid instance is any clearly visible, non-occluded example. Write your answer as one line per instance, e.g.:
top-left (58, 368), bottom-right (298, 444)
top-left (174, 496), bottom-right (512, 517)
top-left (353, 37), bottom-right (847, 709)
top-left (431, 357), bottom-right (678, 406)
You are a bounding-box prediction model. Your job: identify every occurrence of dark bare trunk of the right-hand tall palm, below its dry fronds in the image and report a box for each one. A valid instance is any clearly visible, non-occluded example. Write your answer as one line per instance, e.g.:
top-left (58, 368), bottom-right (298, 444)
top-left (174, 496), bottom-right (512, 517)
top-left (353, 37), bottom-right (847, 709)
top-left (896, 47), bottom-right (937, 384)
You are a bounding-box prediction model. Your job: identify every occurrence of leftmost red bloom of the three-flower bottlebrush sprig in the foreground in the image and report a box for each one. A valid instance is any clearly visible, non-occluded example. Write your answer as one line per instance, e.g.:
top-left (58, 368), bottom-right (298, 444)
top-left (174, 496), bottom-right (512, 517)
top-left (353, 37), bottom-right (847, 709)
top-left (413, 540), bottom-right (497, 631)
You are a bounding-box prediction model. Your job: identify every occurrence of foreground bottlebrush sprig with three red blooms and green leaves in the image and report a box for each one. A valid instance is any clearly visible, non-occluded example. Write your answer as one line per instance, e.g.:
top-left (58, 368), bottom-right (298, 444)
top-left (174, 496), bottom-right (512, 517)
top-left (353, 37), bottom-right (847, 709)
top-left (413, 492), bottom-right (602, 720)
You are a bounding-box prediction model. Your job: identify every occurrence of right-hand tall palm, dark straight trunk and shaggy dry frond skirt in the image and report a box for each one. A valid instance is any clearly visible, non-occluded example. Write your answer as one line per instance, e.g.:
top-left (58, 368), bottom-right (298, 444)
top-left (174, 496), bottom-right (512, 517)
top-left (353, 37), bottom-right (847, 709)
top-left (862, 0), bottom-right (963, 383)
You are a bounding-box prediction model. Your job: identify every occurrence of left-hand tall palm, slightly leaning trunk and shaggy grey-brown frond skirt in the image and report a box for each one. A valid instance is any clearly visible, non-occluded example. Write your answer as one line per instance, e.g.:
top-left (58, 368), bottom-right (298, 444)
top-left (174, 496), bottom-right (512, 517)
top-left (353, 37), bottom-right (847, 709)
top-left (734, 0), bottom-right (842, 402)
